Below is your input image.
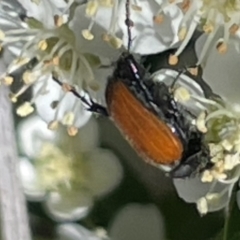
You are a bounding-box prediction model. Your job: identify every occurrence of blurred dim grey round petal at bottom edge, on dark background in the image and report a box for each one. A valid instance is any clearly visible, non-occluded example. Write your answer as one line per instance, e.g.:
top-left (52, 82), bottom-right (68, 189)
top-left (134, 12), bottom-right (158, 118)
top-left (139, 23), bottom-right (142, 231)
top-left (109, 204), bottom-right (165, 240)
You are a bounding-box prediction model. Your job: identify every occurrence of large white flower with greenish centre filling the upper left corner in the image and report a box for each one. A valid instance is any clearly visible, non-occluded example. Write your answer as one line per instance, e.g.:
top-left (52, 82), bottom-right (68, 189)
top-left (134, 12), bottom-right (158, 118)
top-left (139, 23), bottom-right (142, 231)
top-left (0, 0), bottom-right (119, 131)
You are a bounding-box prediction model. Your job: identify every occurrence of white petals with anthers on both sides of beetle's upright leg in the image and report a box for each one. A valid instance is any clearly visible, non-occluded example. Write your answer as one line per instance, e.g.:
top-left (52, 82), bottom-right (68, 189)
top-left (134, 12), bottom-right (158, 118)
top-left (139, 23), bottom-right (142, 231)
top-left (82, 0), bottom-right (183, 54)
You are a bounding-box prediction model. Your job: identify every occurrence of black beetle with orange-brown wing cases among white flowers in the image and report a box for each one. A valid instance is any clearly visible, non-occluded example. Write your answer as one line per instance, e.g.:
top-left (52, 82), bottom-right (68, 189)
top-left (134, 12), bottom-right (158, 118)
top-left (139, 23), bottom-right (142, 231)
top-left (55, 0), bottom-right (211, 178)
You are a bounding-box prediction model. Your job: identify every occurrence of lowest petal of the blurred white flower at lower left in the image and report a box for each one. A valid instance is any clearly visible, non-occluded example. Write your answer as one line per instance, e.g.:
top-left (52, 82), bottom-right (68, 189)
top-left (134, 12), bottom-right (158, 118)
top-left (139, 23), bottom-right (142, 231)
top-left (43, 189), bottom-right (93, 221)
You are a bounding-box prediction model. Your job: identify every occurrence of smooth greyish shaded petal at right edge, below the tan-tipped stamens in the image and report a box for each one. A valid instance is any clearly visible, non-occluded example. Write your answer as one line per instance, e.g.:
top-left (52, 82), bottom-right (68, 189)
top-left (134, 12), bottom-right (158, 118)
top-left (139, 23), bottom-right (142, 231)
top-left (196, 36), bottom-right (240, 104)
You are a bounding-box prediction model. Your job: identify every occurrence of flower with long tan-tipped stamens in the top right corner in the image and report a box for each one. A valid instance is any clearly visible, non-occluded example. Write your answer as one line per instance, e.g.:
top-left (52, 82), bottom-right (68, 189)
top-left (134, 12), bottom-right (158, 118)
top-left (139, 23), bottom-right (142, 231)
top-left (163, 0), bottom-right (240, 65)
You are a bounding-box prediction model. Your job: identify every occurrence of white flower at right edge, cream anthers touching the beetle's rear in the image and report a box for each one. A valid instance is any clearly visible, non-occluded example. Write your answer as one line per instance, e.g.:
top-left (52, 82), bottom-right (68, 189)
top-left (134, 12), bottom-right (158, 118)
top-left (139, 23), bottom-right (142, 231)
top-left (152, 63), bottom-right (240, 214)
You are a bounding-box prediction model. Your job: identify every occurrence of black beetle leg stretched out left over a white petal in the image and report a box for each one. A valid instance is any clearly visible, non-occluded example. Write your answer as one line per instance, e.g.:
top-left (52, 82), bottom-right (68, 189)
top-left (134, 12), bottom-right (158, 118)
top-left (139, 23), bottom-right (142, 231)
top-left (52, 75), bottom-right (109, 117)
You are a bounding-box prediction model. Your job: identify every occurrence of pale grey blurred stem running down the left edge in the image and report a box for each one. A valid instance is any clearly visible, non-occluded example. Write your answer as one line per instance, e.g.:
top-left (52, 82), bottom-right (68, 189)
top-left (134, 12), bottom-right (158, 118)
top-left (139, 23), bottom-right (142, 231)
top-left (0, 86), bottom-right (31, 240)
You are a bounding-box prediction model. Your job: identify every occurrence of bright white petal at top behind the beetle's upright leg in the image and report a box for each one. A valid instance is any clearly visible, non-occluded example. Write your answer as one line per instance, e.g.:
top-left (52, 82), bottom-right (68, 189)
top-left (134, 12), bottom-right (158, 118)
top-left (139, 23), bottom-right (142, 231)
top-left (119, 1), bottom-right (182, 54)
